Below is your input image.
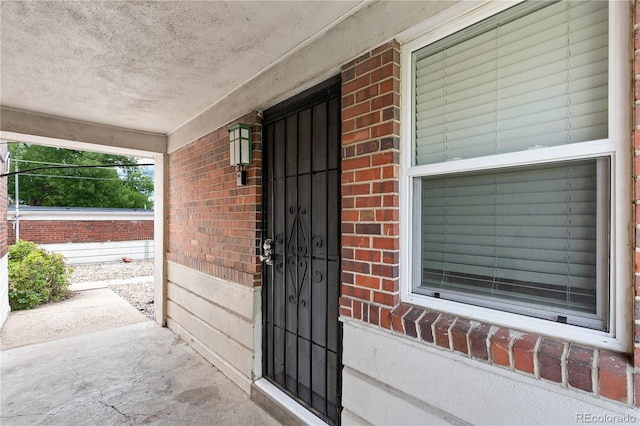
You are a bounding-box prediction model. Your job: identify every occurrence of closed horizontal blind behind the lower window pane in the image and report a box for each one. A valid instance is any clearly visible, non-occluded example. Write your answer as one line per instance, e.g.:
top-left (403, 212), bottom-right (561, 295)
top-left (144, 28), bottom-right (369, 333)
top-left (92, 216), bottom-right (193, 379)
top-left (420, 158), bottom-right (609, 324)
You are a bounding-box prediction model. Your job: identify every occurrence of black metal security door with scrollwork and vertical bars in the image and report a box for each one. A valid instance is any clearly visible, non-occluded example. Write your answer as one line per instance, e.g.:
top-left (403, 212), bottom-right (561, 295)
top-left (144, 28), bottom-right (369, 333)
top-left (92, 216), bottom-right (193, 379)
top-left (263, 75), bottom-right (342, 424)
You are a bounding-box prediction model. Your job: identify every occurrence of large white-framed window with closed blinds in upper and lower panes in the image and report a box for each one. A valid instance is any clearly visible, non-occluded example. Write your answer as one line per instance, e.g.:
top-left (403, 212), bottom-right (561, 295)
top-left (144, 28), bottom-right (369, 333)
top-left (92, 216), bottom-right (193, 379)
top-left (412, 1), bottom-right (612, 331)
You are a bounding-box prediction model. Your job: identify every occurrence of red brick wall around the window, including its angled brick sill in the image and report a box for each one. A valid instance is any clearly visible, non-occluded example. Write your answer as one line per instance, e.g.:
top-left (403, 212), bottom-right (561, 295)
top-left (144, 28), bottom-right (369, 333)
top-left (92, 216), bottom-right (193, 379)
top-left (340, 38), bottom-right (640, 407)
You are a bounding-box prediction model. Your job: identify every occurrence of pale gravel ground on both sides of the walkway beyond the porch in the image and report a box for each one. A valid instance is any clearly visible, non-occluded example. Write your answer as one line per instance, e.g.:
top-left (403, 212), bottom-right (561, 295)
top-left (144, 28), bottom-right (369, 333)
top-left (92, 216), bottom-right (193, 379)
top-left (71, 260), bottom-right (154, 320)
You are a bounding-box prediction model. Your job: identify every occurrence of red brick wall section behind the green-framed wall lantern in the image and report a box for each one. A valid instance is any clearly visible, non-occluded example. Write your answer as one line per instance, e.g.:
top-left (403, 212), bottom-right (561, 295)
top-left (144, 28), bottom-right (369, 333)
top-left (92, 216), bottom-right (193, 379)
top-left (167, 114), bottom-right (262, 286)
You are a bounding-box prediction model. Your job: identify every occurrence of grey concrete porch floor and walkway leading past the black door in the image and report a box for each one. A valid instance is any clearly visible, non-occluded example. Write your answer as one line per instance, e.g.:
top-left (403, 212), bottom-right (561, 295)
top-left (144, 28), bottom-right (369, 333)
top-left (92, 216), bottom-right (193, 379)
top-left (0, 289), bottom-right (277, 426)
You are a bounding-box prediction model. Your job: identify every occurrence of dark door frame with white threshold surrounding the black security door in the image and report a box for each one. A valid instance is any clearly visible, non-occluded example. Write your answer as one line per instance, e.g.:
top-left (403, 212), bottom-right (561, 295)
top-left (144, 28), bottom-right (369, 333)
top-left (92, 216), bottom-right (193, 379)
top-left (256, 74), bottom-right (343, 425)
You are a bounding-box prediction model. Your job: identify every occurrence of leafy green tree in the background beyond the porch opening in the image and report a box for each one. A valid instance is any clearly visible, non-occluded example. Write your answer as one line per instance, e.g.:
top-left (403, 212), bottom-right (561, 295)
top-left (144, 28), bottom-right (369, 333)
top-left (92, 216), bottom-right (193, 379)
top-left (8, 142), bottom-right (153, 208)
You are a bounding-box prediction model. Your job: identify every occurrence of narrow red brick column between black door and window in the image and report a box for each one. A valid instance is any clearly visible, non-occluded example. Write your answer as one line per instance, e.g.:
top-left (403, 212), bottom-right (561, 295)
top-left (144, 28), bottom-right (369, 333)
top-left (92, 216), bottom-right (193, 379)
top-left (340, 42), bottom-right (400, 329)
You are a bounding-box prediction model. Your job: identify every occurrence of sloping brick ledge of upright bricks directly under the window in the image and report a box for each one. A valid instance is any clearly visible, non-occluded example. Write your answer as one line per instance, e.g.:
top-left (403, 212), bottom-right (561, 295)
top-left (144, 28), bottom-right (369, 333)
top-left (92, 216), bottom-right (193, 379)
top-left (347, 303), bottom-right (640, 407)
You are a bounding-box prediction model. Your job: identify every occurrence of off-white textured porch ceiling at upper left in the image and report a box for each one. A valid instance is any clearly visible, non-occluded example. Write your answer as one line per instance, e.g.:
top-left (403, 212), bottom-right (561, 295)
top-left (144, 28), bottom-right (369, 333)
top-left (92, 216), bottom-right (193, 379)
top-left (0, 1), bottom-right (360, 134)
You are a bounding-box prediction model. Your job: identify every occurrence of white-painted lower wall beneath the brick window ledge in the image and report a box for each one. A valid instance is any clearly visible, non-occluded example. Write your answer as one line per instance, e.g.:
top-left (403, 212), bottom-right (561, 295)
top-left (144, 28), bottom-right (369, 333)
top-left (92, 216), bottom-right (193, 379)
top-left (342, 320), bottom-right (640, 425)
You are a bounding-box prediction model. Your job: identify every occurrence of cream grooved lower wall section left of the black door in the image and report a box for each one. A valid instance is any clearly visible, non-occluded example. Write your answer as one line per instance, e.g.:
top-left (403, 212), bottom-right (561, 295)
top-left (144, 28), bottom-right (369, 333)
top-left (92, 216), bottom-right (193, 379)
top-left (167, 262), bottom-right (261, 393)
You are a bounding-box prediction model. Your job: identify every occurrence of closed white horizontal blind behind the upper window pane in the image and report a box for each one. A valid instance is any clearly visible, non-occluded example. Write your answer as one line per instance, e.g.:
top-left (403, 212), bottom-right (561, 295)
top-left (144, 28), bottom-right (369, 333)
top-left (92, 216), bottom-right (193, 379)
top-left (413, 1), bottom-right (608, 165)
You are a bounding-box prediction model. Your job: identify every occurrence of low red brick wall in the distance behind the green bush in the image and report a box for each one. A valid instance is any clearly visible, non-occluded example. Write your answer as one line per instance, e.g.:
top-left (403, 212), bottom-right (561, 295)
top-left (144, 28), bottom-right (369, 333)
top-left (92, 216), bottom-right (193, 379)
top-left (6, 220), bottom-right (153, 244)
